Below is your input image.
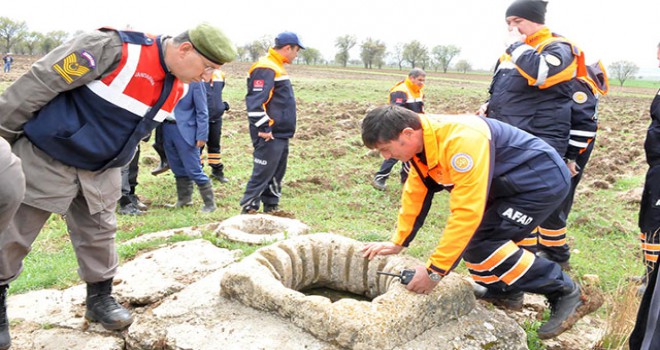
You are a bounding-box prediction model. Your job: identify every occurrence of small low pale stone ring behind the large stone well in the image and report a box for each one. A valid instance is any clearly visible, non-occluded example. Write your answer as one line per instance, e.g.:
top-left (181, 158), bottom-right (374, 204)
top-left (215, 214), bottom-right (309, 244)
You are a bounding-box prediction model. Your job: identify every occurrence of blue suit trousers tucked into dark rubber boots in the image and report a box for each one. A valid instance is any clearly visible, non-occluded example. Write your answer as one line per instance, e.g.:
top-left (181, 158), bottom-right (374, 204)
top-left (163, 123), bottom-right (211, 185)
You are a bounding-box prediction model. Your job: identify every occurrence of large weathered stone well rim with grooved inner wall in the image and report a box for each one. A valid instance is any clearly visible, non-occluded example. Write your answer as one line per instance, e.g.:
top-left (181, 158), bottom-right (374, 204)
top-left (221, 234), bottom-right (475, 349)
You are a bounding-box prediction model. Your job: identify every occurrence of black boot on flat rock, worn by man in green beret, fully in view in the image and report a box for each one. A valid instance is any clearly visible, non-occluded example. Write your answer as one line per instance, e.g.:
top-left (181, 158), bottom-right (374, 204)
top-left (85, 278), bottom-right (133, 331)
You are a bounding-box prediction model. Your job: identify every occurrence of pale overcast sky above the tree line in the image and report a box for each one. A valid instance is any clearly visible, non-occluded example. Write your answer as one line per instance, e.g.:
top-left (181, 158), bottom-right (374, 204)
top-left (0, 0), bottom-right (660, 74)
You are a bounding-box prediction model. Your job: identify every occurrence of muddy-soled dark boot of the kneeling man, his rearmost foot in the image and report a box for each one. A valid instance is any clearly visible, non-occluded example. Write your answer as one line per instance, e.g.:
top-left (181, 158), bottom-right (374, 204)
top-left (537, 282), bottom-right (582, 339)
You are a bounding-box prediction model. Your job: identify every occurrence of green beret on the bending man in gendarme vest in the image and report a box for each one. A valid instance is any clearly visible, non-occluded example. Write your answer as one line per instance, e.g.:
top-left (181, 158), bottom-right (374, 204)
top-left (188, 23), bottom-right (238, 64)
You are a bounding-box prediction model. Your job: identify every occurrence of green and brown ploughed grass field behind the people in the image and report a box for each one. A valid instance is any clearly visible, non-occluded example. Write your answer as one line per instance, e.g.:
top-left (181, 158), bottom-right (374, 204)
top-left (0, 58), bottom-right (660, 349)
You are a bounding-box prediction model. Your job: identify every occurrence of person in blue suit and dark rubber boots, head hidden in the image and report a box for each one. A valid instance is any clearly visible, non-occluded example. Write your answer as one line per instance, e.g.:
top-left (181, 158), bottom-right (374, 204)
top-left (163, 82), bottom-right (216, 213)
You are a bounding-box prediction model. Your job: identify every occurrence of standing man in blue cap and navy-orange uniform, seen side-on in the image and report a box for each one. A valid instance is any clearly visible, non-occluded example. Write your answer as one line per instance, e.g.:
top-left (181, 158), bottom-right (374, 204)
top-left (240, 32), bottom-right (305, 214)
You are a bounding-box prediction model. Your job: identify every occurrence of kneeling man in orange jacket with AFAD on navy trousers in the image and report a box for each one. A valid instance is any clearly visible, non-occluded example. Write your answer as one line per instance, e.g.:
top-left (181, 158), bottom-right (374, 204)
top-left (362, 106), bottom-right (594, 339)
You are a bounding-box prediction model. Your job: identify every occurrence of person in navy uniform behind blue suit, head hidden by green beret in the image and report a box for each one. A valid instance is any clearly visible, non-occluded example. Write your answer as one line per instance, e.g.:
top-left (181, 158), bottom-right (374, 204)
top-left (202, 69), bottom-right (229, 183)
